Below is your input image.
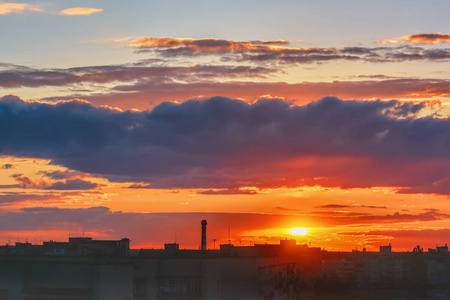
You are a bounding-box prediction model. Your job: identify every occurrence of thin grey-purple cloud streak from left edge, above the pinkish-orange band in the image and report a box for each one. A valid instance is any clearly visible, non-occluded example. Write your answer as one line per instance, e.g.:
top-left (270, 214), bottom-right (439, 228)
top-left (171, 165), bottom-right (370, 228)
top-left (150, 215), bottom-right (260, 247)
top-left (0, 61), bottom-right (277, 88)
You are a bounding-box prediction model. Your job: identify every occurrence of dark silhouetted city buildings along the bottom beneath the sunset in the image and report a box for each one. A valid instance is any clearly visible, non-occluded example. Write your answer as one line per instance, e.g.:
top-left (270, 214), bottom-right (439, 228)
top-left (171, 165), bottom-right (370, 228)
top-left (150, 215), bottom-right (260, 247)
top-left (0, 230), bottom-right (450, 300)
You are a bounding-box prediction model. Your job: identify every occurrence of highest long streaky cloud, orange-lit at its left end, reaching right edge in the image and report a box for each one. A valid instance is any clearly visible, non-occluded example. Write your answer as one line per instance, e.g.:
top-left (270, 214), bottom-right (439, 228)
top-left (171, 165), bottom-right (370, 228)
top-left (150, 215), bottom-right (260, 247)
top-left (128, 37), bottom-right (450, 65)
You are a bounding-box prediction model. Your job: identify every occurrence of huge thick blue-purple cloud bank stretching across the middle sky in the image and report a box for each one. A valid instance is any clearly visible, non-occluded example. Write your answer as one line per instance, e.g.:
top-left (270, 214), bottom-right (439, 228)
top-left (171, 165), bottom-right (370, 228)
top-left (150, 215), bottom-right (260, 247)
top-left (0, 96), bottom-right (450, 193)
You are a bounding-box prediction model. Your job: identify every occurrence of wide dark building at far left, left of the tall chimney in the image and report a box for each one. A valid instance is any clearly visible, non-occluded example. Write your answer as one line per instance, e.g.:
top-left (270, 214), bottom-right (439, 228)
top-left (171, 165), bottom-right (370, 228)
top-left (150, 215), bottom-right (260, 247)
top-left (0, 238), bottom-right (134, 300)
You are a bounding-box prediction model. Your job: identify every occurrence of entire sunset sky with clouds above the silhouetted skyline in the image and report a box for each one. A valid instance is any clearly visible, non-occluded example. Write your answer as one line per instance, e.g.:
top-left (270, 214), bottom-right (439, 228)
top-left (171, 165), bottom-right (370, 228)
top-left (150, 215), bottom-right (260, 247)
top-left (0, 0), bottom-right (450, 251)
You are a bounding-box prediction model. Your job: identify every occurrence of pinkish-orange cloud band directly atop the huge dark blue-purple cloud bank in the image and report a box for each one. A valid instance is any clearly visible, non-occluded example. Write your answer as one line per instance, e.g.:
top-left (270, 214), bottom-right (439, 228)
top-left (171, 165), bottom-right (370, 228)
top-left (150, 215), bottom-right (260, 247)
top-left (44, 78), bottom-right (450, 109)
